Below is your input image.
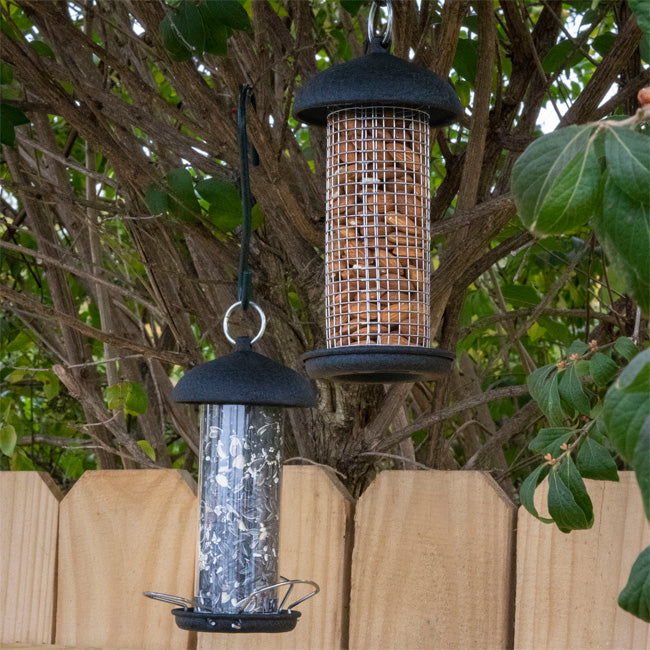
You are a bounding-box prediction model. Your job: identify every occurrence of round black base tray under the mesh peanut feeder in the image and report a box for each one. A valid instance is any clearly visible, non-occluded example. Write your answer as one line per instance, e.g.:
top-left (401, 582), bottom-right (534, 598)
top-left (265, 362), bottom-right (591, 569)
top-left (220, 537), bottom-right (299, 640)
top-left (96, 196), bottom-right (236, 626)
top-left (302, 345), bottom-right (454, 384)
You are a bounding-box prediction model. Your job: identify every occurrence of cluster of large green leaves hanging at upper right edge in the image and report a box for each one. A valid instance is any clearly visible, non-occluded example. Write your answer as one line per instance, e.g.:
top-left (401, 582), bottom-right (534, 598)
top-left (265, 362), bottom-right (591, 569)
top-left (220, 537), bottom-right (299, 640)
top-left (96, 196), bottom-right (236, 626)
top-left (512, 123), bottom-right (650, 313)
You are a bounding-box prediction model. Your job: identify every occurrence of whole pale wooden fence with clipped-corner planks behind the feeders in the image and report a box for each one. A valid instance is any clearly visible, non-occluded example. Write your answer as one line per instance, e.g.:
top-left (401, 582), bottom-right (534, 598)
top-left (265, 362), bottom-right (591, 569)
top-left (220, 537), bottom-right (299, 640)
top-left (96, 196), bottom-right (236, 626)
top-left (0, 467), bottom-right (650, 650)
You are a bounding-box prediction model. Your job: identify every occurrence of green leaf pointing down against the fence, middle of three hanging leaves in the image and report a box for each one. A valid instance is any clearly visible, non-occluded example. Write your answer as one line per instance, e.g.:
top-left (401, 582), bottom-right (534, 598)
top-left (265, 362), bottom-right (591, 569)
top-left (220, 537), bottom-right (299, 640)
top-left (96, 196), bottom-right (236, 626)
top-left (548, 456), bottom-right (594, 533)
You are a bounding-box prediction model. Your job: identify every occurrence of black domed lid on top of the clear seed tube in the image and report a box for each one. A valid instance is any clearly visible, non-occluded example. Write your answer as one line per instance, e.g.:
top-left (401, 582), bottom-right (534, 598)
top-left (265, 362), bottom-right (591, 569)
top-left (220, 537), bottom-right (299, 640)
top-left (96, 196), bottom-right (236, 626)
top-left (173, 336), bottom-right (317, 406)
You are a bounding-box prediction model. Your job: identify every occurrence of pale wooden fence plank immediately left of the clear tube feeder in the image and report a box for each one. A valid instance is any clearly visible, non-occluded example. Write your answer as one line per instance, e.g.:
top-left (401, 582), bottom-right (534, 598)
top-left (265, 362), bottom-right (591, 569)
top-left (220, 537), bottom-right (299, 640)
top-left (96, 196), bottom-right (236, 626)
top-left (56, 470), bottom-right (197, 649)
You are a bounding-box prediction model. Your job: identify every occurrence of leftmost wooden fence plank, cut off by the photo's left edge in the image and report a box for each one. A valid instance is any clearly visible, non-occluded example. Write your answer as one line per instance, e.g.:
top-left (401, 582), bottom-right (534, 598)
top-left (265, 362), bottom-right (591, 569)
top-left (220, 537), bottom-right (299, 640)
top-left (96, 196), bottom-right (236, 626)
top-left (0, 472), bottom-right (61, 643)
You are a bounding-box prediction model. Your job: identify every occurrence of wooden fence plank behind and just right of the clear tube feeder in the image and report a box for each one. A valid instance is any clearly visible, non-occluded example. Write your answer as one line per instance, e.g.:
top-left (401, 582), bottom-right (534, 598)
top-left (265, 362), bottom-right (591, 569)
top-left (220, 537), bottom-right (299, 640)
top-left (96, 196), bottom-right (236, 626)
top-left (198, 467), bottom-right (352, 650)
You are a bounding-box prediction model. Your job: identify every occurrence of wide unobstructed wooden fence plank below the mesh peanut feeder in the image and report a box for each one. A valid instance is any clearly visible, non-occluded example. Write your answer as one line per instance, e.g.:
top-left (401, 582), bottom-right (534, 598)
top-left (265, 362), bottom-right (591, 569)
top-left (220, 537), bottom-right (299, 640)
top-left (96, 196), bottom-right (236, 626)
top-left (350, 471), bottom-right (516, 650)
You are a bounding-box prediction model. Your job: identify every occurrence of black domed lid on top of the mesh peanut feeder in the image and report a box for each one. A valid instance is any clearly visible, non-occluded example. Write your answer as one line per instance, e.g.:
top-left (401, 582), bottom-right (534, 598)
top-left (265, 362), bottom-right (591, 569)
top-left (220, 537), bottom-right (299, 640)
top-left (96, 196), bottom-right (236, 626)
top-left (293, 37), bottom-right (463, 127)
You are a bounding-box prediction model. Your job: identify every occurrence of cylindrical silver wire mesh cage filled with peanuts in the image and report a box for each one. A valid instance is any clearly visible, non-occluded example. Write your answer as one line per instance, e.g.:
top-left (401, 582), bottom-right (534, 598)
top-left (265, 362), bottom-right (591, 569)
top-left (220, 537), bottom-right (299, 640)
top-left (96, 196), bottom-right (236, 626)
top-left (325, 106), bottom-right (431, 348)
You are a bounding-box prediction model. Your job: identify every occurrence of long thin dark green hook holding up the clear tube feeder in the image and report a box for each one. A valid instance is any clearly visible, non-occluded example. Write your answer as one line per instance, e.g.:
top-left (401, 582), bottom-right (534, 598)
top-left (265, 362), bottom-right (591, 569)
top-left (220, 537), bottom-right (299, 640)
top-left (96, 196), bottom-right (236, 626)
top-left (237, 84), bottom-right (259, 310)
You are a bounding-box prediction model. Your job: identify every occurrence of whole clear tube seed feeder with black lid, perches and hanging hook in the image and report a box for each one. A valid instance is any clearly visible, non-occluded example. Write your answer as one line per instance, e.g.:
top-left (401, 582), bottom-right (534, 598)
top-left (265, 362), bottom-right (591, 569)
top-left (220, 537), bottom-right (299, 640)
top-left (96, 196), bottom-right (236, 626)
top-left (145, 86), bottom-right (319, 632)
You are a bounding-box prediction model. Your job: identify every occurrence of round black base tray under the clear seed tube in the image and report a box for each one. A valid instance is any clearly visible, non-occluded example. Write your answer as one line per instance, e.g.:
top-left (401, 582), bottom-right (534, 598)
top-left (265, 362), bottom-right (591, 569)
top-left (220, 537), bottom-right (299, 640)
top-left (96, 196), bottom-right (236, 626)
top-left (172, 608), bottom-right (300, 634)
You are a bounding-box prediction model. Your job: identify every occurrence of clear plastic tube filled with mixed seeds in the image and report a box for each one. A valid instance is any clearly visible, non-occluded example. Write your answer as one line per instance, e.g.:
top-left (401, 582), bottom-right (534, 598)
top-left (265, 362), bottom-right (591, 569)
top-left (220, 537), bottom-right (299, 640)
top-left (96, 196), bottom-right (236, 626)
top-left (196, 404), bottom-right (283, 613)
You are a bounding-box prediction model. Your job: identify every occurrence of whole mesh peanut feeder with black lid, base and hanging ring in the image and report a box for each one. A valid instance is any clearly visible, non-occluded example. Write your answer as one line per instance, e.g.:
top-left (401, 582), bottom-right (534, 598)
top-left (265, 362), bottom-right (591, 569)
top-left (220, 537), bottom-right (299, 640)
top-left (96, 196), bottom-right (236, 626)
top-left (293, 0), bottom-right (462, 383)
